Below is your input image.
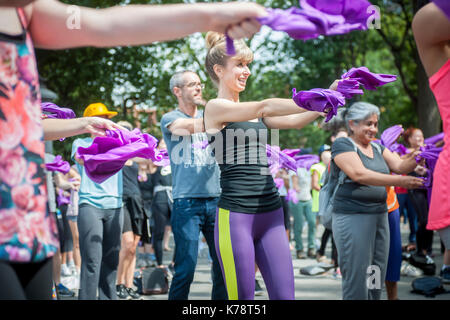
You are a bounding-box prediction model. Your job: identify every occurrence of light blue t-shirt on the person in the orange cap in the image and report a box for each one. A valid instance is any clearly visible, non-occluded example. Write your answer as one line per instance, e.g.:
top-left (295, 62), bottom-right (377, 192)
top-left (72, 137), bottom-right (123, 209)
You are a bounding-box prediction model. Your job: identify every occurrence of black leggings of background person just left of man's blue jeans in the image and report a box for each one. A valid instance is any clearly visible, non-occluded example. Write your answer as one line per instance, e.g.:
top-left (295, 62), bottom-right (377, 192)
top-left (152, 202), bottom-right (171, 265)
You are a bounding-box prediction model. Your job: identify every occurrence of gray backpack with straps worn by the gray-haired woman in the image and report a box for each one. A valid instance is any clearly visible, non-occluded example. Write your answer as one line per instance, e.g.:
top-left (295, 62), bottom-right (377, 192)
top-left (319, 138), bottom-right (381, 230)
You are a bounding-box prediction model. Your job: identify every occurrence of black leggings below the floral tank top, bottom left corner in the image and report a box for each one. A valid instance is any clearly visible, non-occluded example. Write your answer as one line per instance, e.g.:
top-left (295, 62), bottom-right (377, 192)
top-left (0, 258), bottom-right (53, 300)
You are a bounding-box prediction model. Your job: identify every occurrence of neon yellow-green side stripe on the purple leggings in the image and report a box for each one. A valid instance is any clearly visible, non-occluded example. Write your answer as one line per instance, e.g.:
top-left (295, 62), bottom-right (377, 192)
top-left (219, 208), bottom-right (238, 300)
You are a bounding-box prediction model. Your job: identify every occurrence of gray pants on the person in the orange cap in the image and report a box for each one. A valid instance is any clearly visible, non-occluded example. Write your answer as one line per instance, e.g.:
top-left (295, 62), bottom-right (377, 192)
top-left (78, 204), bottom-right (123, 300)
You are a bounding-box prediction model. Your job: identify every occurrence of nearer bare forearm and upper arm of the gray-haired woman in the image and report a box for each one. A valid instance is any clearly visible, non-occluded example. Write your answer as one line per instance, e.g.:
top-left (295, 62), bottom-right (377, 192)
top-left (334, 152), bottom-right (423, 189)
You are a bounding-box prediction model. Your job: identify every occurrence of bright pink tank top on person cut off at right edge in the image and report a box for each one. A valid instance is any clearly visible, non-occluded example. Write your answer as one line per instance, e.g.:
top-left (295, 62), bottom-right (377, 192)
top-left (427, 60), bottom-right (450, 230)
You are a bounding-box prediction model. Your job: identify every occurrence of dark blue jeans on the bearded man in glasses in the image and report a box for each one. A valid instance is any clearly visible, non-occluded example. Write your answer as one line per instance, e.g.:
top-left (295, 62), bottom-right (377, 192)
top-left (169, 198), bottom-right (228, 300)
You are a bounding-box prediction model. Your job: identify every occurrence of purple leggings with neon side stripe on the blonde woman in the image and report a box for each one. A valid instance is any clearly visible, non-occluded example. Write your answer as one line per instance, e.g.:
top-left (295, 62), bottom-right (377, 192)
top-left (214, 208), bottom-right (295, 300)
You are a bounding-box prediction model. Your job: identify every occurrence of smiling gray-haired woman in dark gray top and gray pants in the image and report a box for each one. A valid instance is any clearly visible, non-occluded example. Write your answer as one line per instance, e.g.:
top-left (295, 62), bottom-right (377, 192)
top-left (331, 102), bottom-right (423, 300)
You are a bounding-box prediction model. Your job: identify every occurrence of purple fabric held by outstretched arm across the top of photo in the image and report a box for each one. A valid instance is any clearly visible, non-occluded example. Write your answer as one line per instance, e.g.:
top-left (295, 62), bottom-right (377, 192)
top-left (226, 0), bottom-right (378, 55)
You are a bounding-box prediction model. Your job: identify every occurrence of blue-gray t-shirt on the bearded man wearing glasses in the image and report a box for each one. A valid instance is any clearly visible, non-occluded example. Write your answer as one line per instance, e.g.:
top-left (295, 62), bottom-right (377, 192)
top-left (161, 109), bottom-right (220, 199)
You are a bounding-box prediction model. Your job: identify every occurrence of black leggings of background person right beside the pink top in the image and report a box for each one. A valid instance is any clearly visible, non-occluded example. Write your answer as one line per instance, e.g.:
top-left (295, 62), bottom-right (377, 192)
top-left (408, 189), bottom-right (433, 254)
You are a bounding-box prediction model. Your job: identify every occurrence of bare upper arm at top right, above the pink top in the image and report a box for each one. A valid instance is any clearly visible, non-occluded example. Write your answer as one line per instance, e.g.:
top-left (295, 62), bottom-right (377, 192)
top-left (412, 3), bottom-right (450, 77)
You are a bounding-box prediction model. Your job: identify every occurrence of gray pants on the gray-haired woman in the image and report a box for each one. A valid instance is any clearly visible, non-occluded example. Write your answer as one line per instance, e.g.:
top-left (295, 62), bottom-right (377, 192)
top-left (332, 213), bottom-right (389, 300)
